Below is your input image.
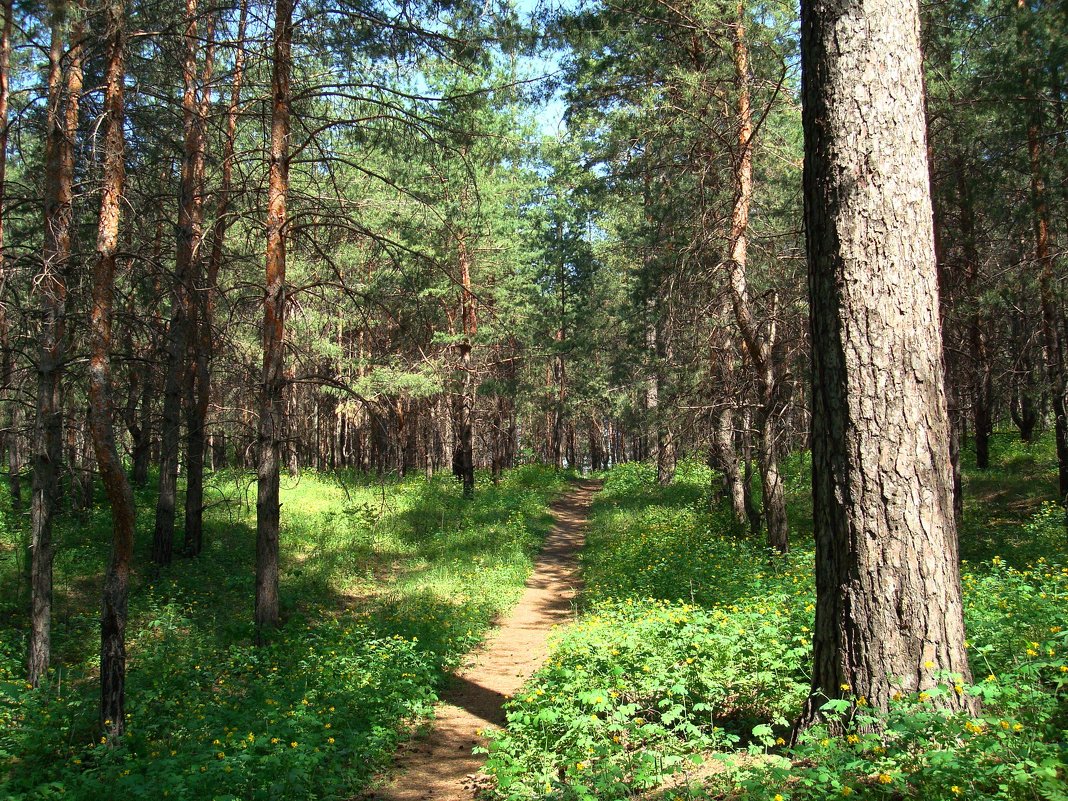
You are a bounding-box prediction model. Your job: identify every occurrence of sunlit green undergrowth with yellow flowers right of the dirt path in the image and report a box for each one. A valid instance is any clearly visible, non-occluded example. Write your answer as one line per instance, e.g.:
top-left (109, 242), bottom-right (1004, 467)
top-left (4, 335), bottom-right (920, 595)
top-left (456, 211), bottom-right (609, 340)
top-left (488, 436), bottom-right (1068, 801)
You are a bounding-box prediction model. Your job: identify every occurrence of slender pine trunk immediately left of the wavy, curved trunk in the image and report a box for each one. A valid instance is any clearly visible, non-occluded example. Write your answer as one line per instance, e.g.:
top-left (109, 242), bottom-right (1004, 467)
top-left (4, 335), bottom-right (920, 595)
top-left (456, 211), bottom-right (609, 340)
top-left (28, 0), bottom-right (82, 687)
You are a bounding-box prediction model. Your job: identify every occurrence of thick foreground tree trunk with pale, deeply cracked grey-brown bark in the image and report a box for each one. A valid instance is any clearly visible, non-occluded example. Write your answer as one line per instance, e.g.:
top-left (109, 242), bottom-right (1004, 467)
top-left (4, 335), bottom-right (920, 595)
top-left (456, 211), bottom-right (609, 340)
top-left (800, 0), bottom-right (970, 725)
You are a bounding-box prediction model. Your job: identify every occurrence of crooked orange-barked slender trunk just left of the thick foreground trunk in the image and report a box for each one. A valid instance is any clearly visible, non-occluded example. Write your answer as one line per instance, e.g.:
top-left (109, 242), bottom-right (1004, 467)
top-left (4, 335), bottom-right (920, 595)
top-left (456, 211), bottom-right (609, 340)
top-left (727, 3), bottom-right (789, 553)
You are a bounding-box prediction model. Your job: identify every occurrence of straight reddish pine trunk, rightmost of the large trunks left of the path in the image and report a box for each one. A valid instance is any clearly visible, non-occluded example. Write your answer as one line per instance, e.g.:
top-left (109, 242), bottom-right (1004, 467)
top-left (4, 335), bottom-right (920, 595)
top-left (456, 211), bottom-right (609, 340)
top-left (255, 0), bottom-right (293, 641)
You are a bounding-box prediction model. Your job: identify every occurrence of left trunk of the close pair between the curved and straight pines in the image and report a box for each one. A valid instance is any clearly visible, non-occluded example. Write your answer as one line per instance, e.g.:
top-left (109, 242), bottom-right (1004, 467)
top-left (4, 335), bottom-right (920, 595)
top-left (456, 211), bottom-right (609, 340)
top-left (152, 0), bottom-right (204, 566)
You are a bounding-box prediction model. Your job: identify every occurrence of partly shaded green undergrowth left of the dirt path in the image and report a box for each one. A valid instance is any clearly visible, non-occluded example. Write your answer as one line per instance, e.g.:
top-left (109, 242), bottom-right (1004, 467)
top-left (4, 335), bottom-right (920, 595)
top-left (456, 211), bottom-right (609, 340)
top-left (0, 467), bottom-right (564, 801)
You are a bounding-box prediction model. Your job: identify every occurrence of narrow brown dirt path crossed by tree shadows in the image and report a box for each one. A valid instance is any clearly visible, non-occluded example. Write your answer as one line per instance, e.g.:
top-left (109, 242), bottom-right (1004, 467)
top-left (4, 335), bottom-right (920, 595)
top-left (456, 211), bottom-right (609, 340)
top-left (365, 482), bottom-right (600, 801)
